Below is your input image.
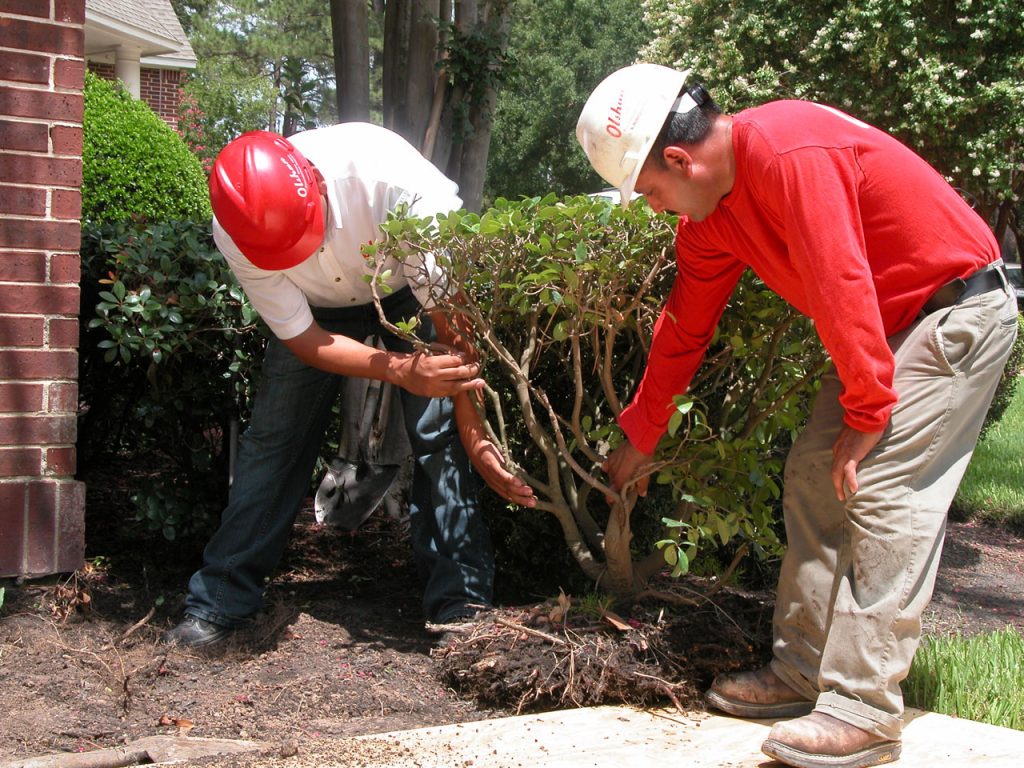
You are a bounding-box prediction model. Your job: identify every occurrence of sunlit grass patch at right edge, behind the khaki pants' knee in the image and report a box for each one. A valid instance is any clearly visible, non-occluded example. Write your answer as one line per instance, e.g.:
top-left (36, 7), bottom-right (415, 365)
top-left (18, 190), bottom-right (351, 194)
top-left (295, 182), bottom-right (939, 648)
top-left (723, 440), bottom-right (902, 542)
top-left (953, 386), bottom-right (1024, 534)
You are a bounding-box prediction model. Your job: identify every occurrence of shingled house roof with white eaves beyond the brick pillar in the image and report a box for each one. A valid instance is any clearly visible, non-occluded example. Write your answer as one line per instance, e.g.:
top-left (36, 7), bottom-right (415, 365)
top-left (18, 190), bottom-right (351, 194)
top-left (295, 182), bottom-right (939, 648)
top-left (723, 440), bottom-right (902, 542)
top-left (85, 0), bottom-right (196, 69)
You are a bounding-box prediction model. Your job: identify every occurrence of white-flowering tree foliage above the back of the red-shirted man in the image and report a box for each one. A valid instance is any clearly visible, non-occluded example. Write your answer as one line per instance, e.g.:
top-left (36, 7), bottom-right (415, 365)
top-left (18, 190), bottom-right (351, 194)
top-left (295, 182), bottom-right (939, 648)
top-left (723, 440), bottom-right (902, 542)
top-left (644, 0), bottom-right (1024, 246)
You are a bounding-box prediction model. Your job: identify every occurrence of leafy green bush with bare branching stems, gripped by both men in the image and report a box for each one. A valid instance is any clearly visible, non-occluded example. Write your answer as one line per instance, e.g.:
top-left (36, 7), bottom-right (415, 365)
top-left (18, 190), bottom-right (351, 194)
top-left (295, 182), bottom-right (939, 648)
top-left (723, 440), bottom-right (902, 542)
top-left (371, 196), bottom-right (823, 596)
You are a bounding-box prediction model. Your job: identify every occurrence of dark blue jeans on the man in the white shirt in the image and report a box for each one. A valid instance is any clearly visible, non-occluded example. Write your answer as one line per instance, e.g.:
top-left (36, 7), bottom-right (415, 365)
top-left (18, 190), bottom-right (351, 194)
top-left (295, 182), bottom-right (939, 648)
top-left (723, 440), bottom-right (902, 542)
top-left (185, 289), bottom-right (495, 627)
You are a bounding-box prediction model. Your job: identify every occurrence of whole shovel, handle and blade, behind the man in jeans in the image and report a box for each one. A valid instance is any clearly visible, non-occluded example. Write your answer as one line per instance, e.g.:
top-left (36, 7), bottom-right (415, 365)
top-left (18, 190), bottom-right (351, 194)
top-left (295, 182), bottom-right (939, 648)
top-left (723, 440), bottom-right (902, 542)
top-left (313, 364), bottom-right (398, 530)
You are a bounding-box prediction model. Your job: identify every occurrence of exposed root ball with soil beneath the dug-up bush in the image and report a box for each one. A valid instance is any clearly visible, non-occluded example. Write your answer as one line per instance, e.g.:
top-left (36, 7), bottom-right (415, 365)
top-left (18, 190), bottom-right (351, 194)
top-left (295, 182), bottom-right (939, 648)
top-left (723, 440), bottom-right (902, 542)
top-left (435, 591), bottom-right (771, 713)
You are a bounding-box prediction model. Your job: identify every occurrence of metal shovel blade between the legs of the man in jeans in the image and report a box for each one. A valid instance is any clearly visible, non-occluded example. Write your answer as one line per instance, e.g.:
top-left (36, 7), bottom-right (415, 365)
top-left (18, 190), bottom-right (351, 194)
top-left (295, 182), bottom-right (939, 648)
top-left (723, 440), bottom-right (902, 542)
top-left (313, 457), bottom-right (398, 530)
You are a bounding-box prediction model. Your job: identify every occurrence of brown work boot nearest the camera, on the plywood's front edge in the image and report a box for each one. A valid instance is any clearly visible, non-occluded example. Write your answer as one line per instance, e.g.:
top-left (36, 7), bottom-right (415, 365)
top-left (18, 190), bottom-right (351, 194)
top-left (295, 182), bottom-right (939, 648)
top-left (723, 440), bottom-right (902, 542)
top-left (761, 712), bottom-right (900, 768)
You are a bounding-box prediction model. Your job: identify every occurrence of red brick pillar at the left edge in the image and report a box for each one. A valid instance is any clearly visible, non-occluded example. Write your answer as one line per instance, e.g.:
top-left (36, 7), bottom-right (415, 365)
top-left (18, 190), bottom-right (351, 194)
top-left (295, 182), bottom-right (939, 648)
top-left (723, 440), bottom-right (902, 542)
top-left (0, 0), bottom-right (85, 577)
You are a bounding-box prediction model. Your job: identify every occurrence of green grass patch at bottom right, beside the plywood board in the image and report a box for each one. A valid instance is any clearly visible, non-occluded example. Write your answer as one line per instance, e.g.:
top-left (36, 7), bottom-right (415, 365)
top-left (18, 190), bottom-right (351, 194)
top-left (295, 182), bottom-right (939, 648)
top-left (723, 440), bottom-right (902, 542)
top-left (903, 627), bottom-right (1024, 730)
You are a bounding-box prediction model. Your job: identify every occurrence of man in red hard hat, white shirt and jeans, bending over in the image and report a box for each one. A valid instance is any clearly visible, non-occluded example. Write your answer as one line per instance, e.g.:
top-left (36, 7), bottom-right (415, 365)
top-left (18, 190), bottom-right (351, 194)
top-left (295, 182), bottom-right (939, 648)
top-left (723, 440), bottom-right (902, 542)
top-left (165, 123), bottom-right (536, 647)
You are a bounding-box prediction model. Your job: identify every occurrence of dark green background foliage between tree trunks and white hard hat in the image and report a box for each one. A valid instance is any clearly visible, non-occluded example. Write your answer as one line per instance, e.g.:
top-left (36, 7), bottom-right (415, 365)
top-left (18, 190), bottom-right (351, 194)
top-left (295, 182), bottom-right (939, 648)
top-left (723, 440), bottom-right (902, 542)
top-left (485, 0), bottom-right (649, 200)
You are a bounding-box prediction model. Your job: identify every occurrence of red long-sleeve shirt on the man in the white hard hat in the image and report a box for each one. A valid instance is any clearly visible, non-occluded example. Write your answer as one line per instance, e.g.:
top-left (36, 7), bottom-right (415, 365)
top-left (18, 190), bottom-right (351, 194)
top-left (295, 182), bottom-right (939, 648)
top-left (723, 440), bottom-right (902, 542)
top-left (618, 101), bottom-right (998, 454)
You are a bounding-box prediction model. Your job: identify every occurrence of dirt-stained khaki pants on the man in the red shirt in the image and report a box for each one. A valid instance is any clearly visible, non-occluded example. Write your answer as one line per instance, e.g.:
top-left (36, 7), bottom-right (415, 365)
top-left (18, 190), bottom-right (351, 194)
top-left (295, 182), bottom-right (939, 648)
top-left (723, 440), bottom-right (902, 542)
top-left (772, 278), bottom-right (1017, 739)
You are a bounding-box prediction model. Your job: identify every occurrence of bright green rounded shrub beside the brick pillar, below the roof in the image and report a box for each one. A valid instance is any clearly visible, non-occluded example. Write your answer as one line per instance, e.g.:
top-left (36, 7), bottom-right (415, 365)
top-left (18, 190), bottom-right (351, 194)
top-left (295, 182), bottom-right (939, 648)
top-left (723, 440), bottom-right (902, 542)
top-left (82, 73), bottom-right (210, 222)
